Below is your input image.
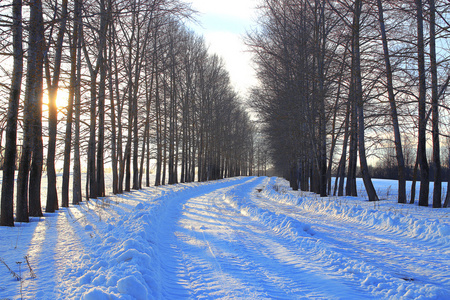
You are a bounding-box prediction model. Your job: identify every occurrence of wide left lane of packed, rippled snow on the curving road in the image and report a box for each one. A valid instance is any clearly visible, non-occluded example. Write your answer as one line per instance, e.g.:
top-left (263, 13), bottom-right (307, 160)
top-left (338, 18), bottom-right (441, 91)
top-left (158, 178), bottom-right (369, 299)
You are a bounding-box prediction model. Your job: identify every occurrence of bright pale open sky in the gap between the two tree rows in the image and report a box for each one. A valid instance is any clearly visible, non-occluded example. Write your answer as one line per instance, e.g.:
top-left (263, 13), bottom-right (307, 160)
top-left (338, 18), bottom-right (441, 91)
top-left (185, 0), bottom-right (258, 98)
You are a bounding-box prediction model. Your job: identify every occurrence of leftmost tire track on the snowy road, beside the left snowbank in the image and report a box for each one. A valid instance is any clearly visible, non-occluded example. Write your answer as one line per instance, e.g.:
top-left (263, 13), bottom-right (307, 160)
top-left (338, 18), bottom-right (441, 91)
top-left (158, 178), bottom-right (270, 299)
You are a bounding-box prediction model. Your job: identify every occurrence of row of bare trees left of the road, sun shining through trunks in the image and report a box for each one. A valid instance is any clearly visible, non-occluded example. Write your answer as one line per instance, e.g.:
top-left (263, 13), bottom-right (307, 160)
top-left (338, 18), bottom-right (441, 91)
top-left (0, 0), bottom-right (253, 226)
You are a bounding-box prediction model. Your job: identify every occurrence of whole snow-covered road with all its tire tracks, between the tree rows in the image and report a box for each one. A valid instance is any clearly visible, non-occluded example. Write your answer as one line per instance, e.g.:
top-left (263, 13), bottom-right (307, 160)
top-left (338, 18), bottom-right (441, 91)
top-left (156, 178), bottom-right (450, 299)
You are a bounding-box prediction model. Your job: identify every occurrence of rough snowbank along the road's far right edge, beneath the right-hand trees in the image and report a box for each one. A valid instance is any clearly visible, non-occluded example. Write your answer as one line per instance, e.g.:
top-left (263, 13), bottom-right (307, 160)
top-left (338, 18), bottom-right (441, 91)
top-left (263, 178), bottom-right (450, 246)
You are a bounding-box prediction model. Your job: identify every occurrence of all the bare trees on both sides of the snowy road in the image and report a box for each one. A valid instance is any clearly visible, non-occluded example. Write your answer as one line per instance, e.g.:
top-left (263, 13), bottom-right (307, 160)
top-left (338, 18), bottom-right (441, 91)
top-left (0, 0), bottom-right (450, 226)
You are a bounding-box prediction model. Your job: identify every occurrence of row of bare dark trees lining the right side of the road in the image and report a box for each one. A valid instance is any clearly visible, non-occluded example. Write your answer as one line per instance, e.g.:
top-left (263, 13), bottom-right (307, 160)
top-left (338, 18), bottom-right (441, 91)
top-left (247, 0), bottom-right (450, 207)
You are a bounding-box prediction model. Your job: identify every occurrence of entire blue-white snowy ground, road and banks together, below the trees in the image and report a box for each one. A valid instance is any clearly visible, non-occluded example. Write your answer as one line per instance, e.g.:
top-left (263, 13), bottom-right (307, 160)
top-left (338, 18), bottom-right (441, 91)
top-left (0, 177), bottom-right (450, 300)
